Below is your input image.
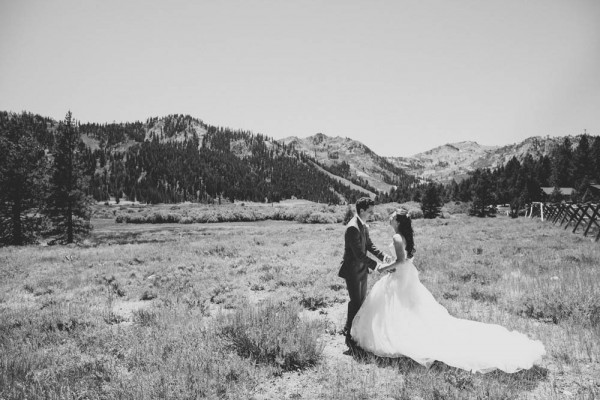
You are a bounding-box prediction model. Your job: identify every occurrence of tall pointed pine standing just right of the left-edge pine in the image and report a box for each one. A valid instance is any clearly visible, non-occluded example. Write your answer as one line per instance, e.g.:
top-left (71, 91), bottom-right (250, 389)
top-left (46, 111), bottom-right (91, 243)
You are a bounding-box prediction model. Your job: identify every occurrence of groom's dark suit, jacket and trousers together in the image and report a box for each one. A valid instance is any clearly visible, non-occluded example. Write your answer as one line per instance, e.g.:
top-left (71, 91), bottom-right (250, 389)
top-left (338, 216), bottom-right (384, 335)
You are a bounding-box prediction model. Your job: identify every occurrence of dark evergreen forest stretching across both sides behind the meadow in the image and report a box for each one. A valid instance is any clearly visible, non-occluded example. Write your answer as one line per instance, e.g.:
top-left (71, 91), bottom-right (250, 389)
top-left (0, 112), bottom-right (600, 242)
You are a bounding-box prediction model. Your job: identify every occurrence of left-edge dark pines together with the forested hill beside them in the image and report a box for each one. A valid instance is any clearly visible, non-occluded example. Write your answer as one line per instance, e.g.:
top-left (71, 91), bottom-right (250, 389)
top-left (0, 112), bottom-right (380, 245)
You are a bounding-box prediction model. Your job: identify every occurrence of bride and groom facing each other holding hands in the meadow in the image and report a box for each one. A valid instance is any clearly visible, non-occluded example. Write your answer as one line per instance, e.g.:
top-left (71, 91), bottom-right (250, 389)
top-left (339, 197), bottom-right (545, 373)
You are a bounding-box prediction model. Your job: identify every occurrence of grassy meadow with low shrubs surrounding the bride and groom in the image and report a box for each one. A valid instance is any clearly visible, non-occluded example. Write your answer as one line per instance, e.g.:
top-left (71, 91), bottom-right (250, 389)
top-left (0, 205), bottom-right (600, 400)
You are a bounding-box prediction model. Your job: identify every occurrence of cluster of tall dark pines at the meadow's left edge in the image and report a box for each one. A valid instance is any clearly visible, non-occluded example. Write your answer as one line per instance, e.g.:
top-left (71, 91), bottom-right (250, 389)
top-left (0, 112), bottom-right (92, 245)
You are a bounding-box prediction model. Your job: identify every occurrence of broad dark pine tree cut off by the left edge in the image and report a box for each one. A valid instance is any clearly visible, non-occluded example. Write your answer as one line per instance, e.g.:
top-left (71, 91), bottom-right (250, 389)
top-left (0, 113), bottom-right (48, 245)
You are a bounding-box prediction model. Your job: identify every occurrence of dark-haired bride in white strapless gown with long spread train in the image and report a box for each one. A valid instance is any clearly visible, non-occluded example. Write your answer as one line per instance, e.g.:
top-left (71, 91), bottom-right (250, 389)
top-left (351, 212), bottom-right (546, 373)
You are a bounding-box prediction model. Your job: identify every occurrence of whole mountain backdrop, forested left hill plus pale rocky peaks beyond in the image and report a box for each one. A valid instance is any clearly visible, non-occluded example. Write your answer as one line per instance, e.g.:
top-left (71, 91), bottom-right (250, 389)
top-left (3, 109), bottom-right (596, 202)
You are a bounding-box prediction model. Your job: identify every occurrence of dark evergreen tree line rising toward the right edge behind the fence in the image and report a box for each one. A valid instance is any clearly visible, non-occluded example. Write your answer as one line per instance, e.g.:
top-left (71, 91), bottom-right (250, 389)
top-left (390, 134), bottom-right (600, 216)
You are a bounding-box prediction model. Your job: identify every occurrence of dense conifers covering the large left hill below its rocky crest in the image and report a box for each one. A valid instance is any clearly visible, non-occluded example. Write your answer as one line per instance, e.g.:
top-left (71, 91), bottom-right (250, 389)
top-left (90, 118), bottom-right (372, 204)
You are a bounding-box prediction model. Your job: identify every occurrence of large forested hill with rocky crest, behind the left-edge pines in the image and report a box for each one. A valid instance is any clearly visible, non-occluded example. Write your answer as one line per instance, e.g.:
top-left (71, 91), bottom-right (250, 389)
top-left (0, 112), bottom-right (375, 204)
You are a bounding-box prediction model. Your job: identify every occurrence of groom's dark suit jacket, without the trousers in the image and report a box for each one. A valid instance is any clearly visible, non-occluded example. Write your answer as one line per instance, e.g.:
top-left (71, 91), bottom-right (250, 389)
top-left (338, 216), bottom-right (384, 280)
